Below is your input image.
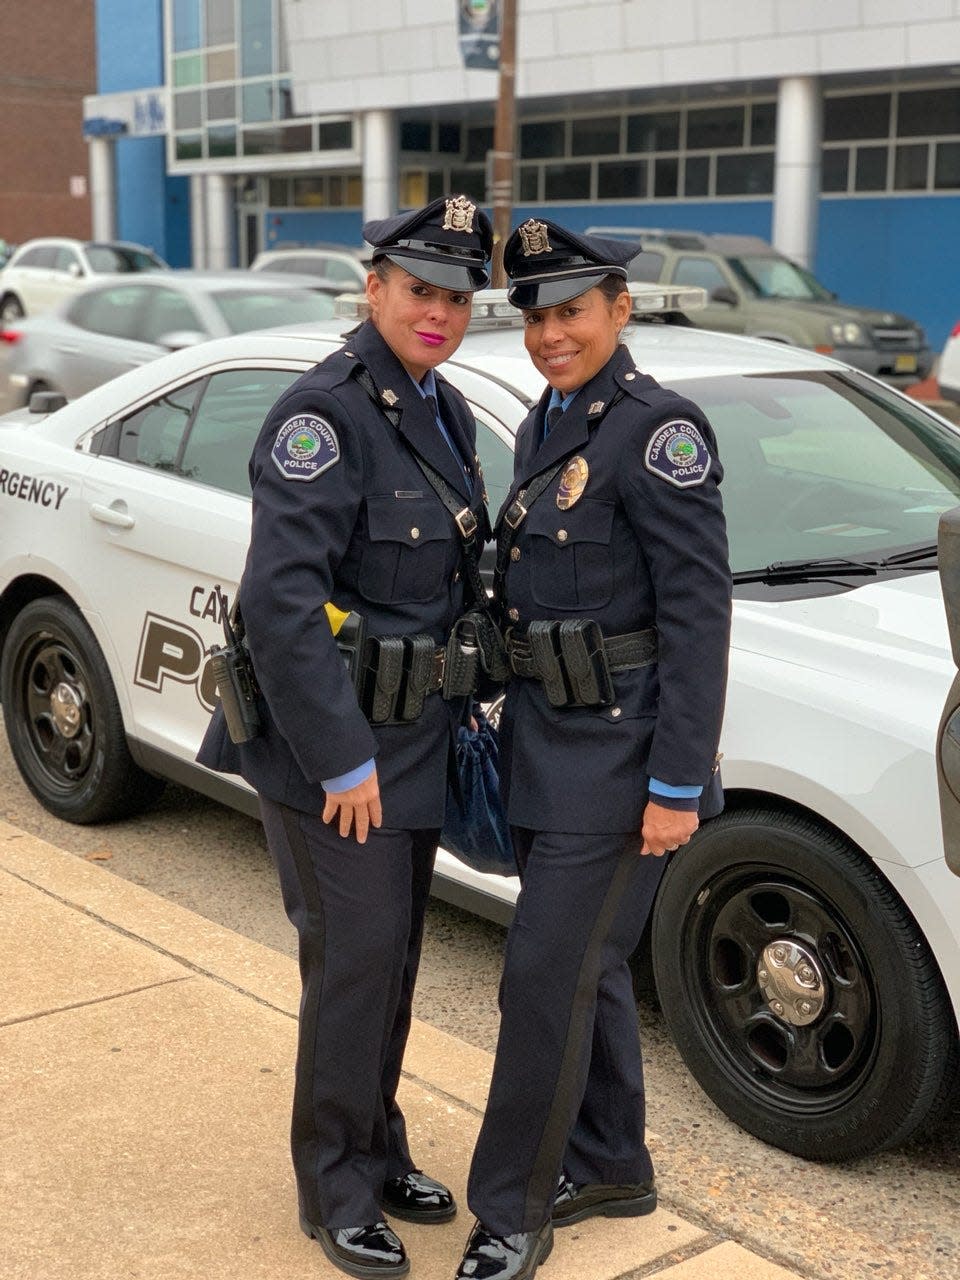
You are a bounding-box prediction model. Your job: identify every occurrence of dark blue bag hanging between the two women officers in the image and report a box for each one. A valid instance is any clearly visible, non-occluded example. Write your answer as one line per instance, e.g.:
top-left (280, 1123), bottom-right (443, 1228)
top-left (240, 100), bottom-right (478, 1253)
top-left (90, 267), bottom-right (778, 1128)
top-left (440, 709), bottom-right (517, 876)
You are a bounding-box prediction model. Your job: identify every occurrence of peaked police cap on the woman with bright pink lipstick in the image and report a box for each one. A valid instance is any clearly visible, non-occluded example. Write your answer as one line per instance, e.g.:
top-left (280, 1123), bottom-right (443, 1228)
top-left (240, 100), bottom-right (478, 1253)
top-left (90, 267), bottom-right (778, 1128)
top-left (364, 196), bottom-right (493, 291)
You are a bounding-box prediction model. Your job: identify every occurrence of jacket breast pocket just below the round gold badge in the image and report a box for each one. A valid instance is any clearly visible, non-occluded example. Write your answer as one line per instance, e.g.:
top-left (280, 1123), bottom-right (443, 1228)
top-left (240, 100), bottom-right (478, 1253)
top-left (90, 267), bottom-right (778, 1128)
top-left (527, 495), bottom-right (613, 609)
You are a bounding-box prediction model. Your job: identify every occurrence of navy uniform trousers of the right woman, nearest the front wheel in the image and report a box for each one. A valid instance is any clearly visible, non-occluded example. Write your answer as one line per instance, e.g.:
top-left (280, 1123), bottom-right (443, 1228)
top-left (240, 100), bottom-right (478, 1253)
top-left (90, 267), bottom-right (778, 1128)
top-left (467, 827), bottom-right (666, 1235)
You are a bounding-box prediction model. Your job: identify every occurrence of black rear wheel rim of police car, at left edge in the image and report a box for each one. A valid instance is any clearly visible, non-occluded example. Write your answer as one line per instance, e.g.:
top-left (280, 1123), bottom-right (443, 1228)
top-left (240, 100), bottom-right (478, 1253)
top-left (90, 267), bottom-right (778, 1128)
top-left (14, 632), bottom-right (96, 795)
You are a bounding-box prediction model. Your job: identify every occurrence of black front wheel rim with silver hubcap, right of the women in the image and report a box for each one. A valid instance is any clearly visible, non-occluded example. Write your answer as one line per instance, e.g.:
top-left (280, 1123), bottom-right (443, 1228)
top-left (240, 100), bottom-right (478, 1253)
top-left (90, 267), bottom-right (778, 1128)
top-left (682, 865), bottom-right (879, 1116)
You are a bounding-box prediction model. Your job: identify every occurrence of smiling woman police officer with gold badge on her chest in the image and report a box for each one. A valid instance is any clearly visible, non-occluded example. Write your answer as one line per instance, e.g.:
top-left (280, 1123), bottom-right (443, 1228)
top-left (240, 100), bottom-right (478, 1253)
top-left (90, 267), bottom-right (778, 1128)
top-left (457, 219), bottom-right (731, 1280)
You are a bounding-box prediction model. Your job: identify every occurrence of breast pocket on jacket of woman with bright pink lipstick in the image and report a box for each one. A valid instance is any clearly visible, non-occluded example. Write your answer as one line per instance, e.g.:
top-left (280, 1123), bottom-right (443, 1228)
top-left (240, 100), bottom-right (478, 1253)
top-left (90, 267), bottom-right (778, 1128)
top-left (358, 495), bottom-right (453, 604)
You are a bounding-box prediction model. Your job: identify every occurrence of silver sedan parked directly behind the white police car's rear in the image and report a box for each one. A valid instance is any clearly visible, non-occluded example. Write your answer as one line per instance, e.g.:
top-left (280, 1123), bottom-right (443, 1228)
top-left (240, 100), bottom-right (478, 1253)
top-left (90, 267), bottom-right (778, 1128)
top-left (0, 271), bottom-right (334, 412)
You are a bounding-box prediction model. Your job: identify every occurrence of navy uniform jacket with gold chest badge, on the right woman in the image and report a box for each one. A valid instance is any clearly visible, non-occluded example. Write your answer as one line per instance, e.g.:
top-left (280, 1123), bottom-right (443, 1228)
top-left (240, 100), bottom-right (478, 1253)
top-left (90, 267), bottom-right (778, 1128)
top-left (500, 347), bottom-right (731, 833)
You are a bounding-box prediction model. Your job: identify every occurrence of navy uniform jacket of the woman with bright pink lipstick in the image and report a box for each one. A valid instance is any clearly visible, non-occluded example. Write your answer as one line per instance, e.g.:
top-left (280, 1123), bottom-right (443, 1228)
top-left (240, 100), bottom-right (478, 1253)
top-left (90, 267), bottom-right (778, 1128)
top-left (197, 321), bottom-right (489, 829)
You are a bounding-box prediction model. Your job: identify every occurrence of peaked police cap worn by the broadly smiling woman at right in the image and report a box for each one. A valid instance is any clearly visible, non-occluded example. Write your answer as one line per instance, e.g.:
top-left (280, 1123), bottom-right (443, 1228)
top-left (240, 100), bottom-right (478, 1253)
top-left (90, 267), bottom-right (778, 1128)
top-left (503, 218), bottom-right (640, 310)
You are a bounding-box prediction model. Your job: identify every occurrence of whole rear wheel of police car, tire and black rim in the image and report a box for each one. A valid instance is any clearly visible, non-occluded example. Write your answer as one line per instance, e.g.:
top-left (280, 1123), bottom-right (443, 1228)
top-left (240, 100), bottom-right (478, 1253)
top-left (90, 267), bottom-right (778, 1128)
top-left (0, 596), bottom-right (164, 824)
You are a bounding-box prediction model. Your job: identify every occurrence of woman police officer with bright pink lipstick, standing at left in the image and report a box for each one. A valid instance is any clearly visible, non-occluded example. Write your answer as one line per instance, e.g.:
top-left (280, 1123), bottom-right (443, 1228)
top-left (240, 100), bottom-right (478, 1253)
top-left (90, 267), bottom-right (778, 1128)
top-left (198, 196), bottom-right (493, 1276)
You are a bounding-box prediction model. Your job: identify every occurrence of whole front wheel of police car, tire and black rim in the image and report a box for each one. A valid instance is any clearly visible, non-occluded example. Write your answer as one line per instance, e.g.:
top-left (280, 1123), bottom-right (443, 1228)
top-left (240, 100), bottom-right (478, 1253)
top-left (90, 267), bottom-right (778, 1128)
top-left (652, 809), bottom-right (957, 1161)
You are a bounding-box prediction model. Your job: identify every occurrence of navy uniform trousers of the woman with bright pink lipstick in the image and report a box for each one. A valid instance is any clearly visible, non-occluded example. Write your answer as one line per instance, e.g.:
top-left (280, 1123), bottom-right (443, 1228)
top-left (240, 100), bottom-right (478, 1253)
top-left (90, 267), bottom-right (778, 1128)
top-left (260, 796), bottom-right (439, 1229)
